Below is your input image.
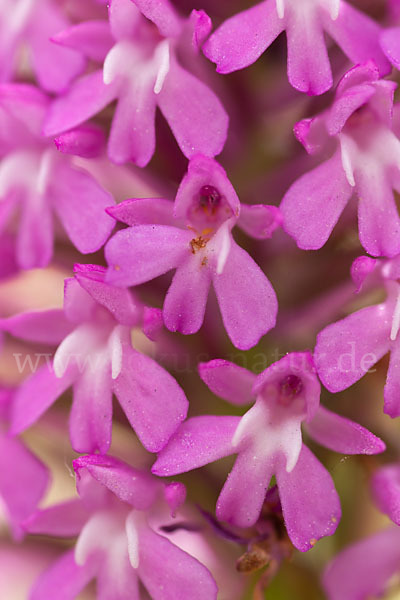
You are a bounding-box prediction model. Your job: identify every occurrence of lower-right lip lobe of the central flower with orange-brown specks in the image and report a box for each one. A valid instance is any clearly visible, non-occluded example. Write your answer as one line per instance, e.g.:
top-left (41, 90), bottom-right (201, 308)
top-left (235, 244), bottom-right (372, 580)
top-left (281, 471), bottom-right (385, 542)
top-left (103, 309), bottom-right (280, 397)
top-left (213, 240), bottom-right (278, 350)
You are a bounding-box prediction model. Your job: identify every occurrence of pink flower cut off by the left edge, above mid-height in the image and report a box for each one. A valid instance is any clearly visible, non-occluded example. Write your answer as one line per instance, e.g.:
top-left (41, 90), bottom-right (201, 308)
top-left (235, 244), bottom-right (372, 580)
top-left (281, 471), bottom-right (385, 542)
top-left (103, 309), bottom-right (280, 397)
top-left (0, 84), bottom-right (113, 269)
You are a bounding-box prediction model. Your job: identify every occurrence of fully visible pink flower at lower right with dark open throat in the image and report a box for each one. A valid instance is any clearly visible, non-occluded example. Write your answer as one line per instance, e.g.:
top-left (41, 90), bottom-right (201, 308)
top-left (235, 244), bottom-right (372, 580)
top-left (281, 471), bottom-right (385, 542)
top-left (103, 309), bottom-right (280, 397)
top-left (152, 352), bottom-right (385, 552)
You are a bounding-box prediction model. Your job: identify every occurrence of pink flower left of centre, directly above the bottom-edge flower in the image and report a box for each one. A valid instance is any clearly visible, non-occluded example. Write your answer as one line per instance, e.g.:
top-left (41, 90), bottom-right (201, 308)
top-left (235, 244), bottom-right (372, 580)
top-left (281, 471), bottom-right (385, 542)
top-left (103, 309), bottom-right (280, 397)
top-left (1, 265), bottom-right (188, 453)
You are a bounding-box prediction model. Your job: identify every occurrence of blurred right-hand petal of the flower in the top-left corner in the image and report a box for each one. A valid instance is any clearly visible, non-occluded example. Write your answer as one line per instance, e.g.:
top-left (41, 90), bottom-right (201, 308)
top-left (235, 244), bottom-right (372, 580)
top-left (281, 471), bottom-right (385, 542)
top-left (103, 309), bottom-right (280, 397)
top-left (29, 2), bottom-right (85, 92)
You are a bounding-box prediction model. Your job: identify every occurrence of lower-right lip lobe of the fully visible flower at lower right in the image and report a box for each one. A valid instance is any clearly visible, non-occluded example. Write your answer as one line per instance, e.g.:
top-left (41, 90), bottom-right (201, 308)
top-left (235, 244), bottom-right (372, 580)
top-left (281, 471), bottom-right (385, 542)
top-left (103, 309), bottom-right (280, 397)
top-left (276, 445), bottom-right (341, 552)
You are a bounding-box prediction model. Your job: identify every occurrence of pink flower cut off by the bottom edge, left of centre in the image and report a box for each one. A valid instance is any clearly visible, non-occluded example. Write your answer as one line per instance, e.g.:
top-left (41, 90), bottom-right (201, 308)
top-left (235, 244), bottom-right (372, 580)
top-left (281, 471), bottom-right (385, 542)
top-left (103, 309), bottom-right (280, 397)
top-left (26, 455), bottom-right (217, 600)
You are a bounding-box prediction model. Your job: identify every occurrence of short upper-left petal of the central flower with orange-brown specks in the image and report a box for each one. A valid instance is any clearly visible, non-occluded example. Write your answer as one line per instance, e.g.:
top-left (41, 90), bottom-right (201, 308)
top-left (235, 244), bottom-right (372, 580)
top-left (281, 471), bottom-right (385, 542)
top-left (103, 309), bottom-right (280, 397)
top-left (107, 198), bottom-right (176, 227)
